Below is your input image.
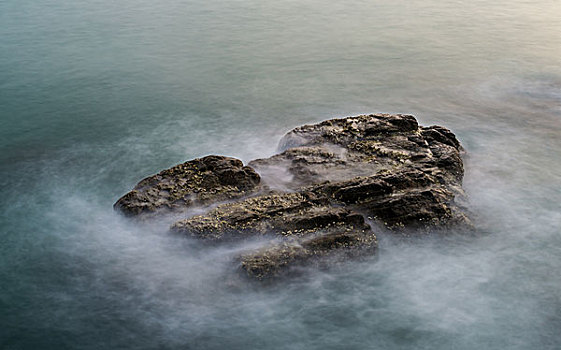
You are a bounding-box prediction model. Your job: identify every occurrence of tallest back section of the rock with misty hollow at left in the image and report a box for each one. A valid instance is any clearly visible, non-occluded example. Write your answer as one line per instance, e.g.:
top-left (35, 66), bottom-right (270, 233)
top-left (248, 114), bottom-right (463, 190)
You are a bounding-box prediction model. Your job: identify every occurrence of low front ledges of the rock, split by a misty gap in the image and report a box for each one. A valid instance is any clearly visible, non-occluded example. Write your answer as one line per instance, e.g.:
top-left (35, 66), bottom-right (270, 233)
top-left (172, 192), bottom-right (376, 279)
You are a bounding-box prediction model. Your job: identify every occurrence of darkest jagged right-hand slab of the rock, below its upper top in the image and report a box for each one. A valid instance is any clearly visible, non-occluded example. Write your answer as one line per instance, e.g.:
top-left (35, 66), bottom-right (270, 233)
top-left (311, 168), bottom-right (470, 229)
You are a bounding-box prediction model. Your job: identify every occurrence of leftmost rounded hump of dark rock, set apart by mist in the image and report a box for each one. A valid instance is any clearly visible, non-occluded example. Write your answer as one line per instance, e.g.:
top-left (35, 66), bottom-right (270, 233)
top-left (114, 156), bottom-right (260, 216)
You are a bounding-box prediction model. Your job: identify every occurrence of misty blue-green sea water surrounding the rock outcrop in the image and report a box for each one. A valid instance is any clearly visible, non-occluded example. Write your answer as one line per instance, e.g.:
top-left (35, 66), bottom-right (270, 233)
top-left (0, 0), bottom-right (561, 350)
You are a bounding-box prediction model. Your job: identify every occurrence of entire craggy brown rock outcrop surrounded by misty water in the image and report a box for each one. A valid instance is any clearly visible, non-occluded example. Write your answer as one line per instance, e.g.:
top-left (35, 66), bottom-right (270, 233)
top-left (115, 114), bottom-right (469, 279)
